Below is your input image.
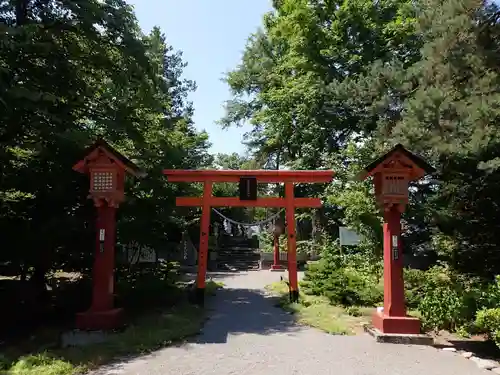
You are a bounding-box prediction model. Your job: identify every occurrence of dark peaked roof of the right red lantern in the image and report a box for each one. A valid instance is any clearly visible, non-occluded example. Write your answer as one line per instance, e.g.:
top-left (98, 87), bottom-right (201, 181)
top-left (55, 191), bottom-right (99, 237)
top-left (358, 143), bottom-right (436, 179)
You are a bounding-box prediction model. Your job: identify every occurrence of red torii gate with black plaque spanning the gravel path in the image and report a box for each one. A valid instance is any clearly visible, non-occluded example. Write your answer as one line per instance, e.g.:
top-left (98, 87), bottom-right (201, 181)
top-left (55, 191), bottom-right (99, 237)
top-left (163, 169), bottom-right (334, 304)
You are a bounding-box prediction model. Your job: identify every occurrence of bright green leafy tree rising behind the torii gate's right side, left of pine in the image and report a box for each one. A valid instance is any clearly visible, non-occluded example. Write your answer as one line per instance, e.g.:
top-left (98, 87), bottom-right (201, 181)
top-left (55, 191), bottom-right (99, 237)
top-left (221, 0), bottom-right (421, 250)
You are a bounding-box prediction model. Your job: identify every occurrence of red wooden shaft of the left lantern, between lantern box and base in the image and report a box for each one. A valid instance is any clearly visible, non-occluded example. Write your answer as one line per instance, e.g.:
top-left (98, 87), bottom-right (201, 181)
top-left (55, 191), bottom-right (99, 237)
top-left (90, 202), bottom-right (116, 312)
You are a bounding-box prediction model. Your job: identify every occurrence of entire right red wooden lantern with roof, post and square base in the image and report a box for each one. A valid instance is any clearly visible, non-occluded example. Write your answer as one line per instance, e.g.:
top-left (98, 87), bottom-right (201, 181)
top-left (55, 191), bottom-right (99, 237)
top-left (362, 144), bottom-right (435, 334)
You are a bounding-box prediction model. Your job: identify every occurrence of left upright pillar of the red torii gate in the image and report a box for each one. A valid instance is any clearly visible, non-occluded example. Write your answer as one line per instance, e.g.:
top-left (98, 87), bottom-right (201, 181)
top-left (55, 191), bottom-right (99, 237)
top-left (196, 181), bottom-right (212, 305)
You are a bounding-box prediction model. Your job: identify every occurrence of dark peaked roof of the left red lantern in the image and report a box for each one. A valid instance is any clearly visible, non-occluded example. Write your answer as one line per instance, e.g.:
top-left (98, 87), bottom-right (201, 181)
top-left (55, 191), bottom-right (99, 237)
top-left (73, 138), bottom-right (146, 177)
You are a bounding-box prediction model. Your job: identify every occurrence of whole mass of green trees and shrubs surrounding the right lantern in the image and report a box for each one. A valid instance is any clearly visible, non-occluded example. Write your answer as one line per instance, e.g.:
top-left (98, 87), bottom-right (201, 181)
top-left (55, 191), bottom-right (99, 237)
top-left (221, 0), bottom-right (500, 344)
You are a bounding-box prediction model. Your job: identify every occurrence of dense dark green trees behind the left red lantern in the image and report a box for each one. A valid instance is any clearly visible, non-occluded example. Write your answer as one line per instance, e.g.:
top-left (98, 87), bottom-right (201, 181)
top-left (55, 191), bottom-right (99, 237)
top-left (0, 0), bottom-right (210, 282)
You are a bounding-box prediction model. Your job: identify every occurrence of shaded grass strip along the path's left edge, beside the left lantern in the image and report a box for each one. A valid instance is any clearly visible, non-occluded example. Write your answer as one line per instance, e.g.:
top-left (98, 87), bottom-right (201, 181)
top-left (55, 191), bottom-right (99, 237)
top-left (0, 281), bottom-right (222, 375)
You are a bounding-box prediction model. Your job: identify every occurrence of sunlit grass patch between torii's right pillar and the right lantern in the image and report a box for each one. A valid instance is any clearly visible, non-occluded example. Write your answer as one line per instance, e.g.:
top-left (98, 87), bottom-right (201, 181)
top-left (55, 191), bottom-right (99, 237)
top-left (266, 281), bottom-right (373, 335)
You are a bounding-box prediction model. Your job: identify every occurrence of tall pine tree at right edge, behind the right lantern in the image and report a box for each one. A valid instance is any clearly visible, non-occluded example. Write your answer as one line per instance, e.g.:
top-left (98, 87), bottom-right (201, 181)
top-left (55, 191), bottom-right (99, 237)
top-left (393, 0), bottom-right (500, 276)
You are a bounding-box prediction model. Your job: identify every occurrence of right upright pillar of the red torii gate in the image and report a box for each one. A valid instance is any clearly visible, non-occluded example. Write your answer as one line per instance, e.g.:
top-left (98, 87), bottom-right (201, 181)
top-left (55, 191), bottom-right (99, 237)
top-left (285, 182), bottom-right (299, 302)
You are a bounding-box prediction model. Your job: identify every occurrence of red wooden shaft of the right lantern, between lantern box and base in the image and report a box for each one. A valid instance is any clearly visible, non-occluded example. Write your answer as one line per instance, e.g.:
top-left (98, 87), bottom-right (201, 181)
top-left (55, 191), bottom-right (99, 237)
top-left (384, 207), bottom-right (406, 317)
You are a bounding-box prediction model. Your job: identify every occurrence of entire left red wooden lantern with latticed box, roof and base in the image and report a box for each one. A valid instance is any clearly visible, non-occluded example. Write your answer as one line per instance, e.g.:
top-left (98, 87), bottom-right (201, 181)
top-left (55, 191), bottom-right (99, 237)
top-left (73, 140), bottom-right (141, 330)
